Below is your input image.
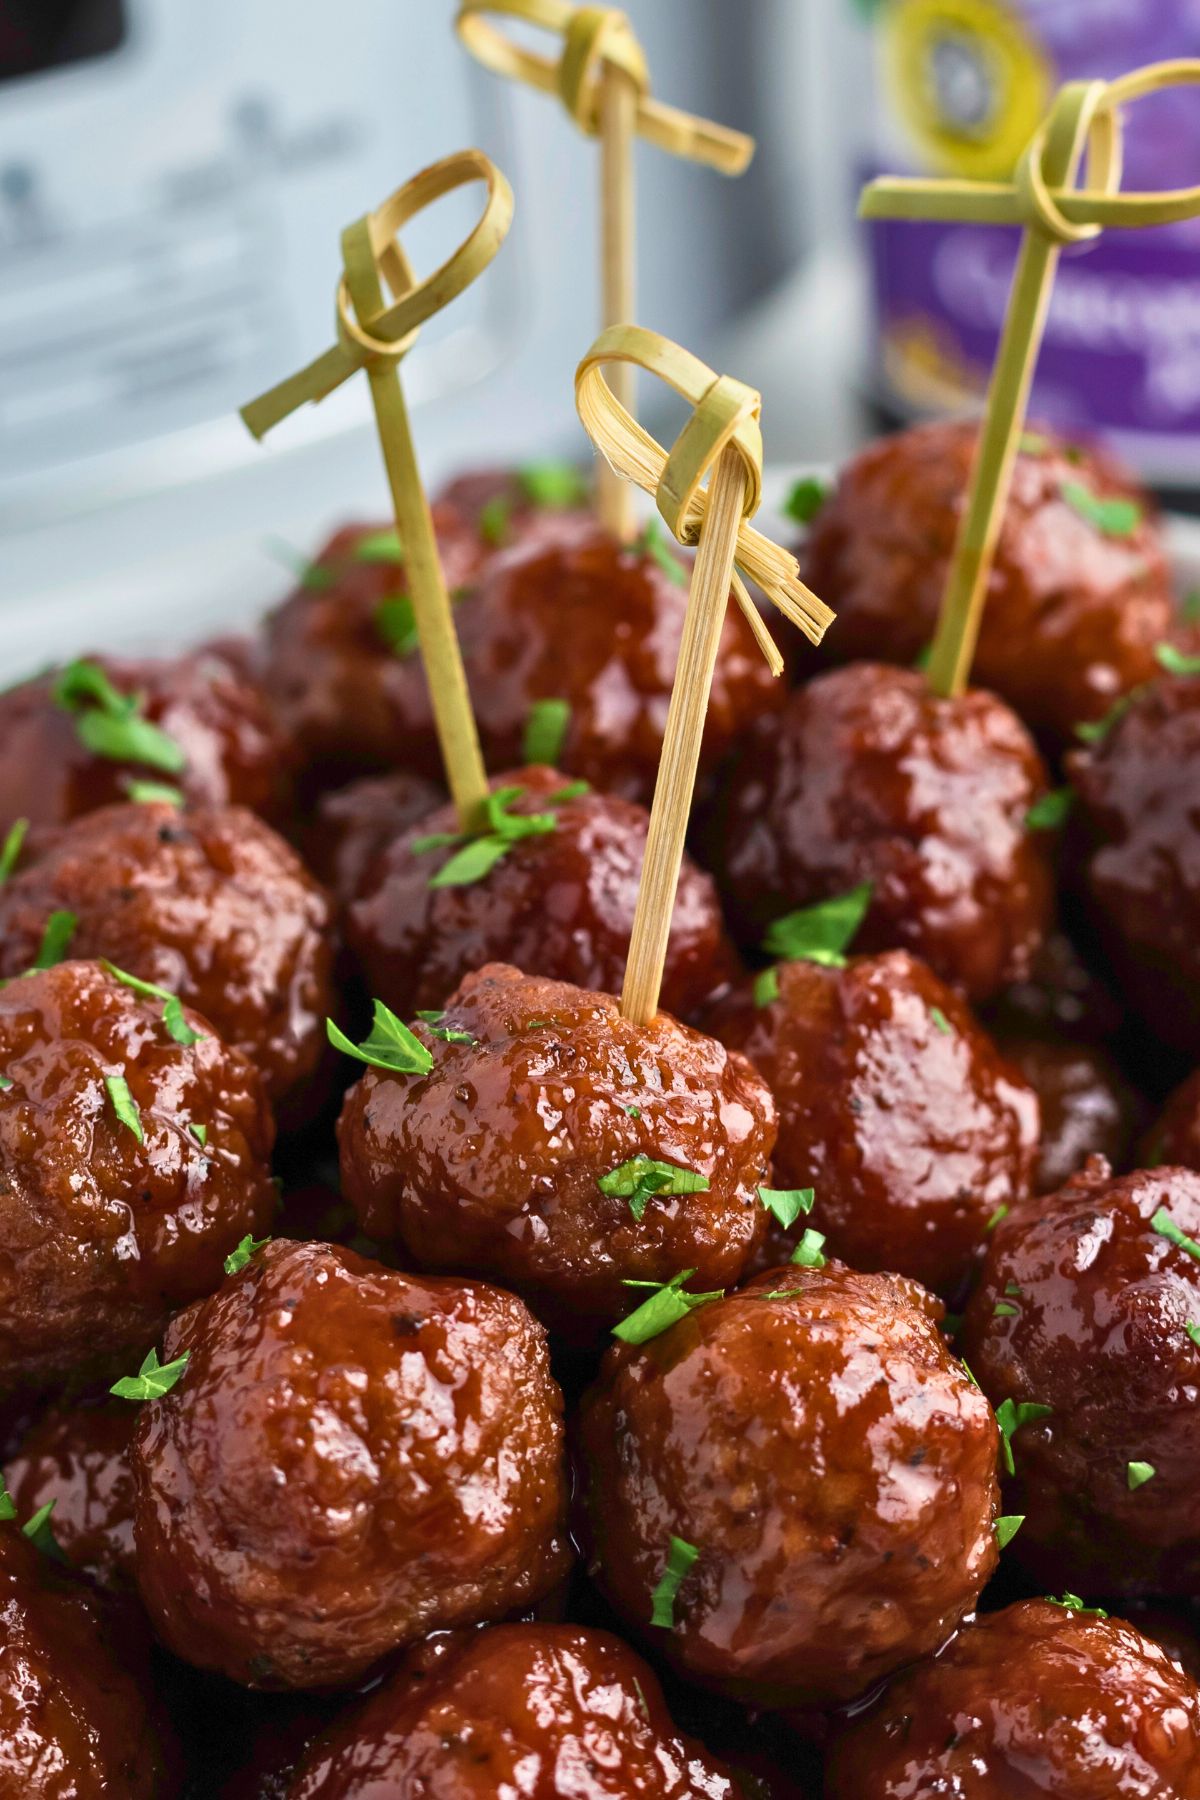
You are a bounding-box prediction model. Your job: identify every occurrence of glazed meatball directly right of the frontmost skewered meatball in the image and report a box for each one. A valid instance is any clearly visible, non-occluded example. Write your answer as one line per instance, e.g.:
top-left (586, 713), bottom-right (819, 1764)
top-left (709, 950), bottom-right (1038, 1296)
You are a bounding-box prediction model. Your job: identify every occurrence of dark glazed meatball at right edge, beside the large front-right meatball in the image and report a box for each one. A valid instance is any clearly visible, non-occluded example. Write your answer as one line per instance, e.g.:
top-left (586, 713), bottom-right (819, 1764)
top-left (963, 1157), bottom-right (1200, 1593)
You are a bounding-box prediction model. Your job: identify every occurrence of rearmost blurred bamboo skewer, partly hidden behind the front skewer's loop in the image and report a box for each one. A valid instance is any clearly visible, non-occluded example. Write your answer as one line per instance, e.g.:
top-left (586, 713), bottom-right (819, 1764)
top-left (455, 0), bottom-right (754, 544)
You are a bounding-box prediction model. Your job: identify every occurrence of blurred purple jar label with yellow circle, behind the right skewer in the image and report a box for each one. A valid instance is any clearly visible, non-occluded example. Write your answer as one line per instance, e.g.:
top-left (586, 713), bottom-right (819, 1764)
top-left (864, 0), bottom-right (1200, 486)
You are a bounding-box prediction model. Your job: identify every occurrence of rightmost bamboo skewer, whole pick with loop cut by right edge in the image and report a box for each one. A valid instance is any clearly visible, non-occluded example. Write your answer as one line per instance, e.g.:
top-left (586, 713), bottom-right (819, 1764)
top-left (860, 59), bottom-right (1200, 697)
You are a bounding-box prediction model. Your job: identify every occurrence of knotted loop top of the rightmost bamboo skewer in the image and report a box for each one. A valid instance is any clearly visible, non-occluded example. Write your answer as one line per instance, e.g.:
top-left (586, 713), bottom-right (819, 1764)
top-left (858, 58), bottom-right (1200, 245)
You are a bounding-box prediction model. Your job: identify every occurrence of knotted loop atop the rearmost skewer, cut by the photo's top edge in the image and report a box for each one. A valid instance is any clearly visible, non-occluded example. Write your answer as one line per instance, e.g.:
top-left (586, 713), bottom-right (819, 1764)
top-left (455, 0), bottom-right (754, 175)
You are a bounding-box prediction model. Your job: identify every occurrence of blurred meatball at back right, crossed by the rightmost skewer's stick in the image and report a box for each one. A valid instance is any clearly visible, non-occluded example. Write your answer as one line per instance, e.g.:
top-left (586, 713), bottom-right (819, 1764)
top-left (804, 421), bottom-right (1175, 742)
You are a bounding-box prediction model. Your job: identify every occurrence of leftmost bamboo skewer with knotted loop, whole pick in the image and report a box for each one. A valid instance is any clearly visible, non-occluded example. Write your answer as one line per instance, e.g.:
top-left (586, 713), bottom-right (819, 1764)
top-left (241, 149), bottom-right (513, 832)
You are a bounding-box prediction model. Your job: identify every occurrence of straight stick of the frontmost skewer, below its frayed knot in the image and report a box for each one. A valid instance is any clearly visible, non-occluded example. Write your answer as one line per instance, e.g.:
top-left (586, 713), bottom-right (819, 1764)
top-left (621, 450), bottom-right (747, 1024)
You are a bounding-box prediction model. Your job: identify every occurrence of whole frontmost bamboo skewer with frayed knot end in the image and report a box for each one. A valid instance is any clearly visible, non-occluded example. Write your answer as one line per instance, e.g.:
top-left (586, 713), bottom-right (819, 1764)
top-left (576, 326), bottom-right (833, 1024)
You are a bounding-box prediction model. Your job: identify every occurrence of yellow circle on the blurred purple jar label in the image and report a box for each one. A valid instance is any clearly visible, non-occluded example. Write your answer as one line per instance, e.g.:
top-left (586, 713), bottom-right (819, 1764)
top-left (882, 0), bottom-right (1052, 180)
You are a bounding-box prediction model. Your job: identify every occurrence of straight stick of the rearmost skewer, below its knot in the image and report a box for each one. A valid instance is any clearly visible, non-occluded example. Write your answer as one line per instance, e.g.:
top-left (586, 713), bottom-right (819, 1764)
top-left (596, 63), bottom-right (639, 544)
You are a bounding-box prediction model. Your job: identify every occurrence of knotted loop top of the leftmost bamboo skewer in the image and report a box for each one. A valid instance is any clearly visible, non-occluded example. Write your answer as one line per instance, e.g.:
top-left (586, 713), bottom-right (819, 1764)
top-left (241, 149), bottom-right (513, 437)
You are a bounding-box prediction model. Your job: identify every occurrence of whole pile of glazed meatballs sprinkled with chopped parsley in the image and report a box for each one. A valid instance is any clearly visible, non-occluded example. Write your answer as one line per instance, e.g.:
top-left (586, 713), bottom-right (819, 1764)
top-left (0, 439), bottom-right (1200, 1800)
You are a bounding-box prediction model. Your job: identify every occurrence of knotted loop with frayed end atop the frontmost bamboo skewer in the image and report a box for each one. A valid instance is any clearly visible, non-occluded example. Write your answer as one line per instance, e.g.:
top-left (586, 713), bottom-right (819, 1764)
top-left (576, 326), bottom-right (833, 675)
